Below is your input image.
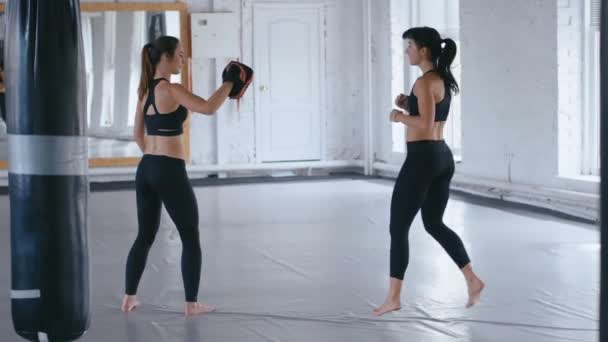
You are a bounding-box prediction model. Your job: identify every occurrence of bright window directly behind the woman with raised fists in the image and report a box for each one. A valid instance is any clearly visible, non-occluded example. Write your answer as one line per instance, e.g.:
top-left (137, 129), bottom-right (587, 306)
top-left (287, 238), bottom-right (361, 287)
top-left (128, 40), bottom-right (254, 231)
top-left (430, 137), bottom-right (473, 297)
top-left (391, 0), bottom-right (462, 159)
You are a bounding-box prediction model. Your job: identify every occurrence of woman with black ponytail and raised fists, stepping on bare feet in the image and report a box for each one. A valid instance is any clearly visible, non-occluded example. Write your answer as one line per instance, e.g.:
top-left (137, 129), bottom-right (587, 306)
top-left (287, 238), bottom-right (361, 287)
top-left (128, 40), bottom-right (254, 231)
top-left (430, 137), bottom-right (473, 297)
top-left (374, 27), bottom-right (484, 316)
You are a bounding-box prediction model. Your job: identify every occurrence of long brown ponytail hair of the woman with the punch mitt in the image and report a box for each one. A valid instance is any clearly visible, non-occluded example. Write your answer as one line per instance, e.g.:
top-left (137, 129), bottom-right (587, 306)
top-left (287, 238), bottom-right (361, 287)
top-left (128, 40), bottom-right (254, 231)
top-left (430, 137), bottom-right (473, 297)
top-left (137, 36), bottom-right (179, 100)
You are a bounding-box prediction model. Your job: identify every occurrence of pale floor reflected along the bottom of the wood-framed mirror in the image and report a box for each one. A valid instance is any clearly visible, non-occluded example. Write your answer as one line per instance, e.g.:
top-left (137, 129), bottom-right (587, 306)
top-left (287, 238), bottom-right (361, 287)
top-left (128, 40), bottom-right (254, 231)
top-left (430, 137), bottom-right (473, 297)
top-left (0, 137), bottom-right (141, 160)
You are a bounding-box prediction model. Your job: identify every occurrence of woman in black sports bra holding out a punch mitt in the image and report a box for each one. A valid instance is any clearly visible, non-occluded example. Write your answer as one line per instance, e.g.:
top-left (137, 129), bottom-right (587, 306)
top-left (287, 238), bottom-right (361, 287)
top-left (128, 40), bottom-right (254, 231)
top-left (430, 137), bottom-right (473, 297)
top-left (122, 36), bottom-right (253, 315)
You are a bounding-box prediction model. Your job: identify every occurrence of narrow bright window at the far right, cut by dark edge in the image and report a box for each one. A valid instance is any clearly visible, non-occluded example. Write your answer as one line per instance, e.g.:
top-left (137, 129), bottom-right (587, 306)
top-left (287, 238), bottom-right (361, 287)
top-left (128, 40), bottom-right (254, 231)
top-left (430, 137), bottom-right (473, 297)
top-left (582, 0), bottom-right (601, 175)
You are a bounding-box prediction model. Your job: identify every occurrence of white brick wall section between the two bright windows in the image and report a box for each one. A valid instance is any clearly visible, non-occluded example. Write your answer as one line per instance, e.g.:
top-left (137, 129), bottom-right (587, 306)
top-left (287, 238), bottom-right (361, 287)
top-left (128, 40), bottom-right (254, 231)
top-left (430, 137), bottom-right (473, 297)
top-left (458, 0), bottom-right (558, 185)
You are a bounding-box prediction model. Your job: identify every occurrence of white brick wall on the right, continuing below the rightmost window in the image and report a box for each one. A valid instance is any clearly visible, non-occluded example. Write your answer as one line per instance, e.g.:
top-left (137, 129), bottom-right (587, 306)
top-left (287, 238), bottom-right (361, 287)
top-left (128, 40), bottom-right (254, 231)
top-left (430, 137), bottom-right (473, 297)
top-left (454, 0), bottom-right (599, 219)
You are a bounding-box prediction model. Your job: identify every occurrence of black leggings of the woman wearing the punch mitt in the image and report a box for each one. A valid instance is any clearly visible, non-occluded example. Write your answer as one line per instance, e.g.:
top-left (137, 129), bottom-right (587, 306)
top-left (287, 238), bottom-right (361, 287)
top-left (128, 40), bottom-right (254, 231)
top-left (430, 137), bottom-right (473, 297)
top-left (126, 154), bottom-right (202, 302)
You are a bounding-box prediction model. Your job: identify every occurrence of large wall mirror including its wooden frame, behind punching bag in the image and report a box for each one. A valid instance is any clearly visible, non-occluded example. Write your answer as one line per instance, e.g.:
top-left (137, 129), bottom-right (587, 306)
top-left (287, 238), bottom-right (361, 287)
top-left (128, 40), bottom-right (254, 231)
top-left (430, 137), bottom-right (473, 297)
top-left (0, 3), bottom-right (189, 168)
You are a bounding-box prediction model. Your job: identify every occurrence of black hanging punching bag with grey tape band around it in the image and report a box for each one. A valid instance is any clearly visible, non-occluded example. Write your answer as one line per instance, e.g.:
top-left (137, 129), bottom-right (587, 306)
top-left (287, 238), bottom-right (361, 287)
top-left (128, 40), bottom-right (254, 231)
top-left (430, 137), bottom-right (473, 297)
top-left (5, 0), bottom-right (90, 342)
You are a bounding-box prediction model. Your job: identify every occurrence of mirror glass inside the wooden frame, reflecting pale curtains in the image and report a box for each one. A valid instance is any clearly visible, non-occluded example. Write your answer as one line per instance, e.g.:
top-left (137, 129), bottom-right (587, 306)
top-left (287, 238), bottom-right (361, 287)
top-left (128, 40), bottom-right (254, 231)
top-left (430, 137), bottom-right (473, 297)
top-left (81, 11), bottom-right (180, 164)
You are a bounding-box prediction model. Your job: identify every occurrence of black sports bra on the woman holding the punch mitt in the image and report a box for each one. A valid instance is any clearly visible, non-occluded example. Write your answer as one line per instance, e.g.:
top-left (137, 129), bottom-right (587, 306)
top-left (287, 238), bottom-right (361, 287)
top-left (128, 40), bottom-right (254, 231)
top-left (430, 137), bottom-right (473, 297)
top-left (144, 78), bottom-right (188, 137)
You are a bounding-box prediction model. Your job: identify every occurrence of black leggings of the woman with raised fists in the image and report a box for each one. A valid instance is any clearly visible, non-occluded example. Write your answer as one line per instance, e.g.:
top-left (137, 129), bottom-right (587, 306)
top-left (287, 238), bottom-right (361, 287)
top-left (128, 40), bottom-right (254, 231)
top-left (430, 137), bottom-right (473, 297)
top-left (390, 140), bottom-right (470, 279)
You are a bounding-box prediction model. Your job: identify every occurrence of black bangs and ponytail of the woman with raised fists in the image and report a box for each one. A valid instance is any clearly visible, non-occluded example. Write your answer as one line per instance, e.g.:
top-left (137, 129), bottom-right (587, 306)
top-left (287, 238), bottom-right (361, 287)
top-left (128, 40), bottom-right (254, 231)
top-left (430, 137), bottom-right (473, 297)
top-left (402, 26), bottom-right (460, 94)
